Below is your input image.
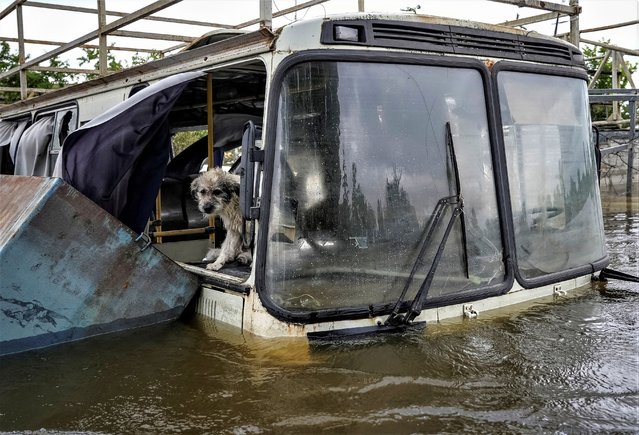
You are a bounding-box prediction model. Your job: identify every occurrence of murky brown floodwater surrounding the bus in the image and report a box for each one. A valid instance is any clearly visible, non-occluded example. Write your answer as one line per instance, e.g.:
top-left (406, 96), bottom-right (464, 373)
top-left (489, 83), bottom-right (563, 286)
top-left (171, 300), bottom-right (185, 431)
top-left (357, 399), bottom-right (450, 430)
top-left (0, 189), bottom-right (639, 434)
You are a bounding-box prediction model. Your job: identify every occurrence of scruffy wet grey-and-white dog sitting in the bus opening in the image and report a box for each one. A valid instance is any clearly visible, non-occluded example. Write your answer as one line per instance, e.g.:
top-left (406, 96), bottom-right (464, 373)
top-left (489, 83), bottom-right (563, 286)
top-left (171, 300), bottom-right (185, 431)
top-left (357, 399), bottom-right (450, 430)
top-left (191, 168), bottom-right (252, 270)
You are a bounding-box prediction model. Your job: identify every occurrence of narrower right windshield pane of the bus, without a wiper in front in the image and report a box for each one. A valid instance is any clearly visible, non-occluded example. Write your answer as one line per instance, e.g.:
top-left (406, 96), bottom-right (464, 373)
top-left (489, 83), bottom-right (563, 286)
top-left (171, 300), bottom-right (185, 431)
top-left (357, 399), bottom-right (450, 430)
top-left (498, 71), bottom-right (605, 278)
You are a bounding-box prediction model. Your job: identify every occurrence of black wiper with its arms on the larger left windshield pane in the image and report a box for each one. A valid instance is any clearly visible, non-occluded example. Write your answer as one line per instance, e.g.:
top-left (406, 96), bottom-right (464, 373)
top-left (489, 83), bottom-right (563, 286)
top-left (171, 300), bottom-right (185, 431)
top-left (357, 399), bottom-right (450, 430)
top-left (384, 122), bottom-right (468, 326)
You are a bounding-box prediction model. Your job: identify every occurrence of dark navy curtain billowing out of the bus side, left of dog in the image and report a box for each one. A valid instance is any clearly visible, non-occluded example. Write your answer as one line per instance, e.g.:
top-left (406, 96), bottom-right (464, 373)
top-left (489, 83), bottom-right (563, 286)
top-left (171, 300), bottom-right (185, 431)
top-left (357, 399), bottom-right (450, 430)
top-left (61, 73), bottom-right (203, 233)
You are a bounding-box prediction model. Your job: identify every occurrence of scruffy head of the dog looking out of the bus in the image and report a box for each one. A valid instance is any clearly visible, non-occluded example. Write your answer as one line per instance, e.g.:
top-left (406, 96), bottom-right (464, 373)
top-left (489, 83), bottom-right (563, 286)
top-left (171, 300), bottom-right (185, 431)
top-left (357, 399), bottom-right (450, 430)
top-left (191, 168), bottom-right (240, 215)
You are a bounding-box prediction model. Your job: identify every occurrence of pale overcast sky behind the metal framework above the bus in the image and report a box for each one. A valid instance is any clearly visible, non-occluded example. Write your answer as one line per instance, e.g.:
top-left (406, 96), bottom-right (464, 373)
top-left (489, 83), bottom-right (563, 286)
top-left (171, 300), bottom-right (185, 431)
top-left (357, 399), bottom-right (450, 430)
top-left (0, 0), bottom-right (639, 82)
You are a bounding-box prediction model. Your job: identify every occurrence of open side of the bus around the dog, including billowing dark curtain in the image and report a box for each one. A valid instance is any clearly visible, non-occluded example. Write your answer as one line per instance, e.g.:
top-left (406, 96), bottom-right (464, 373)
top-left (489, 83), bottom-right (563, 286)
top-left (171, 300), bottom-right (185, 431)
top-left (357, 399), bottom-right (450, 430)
top-left (48, 61), bottom-right (266, 277)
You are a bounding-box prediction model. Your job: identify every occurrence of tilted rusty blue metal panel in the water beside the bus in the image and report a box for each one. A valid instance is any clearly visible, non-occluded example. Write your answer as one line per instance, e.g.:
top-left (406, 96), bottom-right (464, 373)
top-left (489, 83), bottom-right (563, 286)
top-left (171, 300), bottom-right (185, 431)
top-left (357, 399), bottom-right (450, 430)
top-left (0, 176), bottom-right (198, 355)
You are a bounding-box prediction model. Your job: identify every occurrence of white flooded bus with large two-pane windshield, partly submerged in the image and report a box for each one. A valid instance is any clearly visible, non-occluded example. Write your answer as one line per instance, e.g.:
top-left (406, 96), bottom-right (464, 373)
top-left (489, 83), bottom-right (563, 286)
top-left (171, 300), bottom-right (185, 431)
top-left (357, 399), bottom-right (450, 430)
top-left (0, 14), bottom-right (608, 352)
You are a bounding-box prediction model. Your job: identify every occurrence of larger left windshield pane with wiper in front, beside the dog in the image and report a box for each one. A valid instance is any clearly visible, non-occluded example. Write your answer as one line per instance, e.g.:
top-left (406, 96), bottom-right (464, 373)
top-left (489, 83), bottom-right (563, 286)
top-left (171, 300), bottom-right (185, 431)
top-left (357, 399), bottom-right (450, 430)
top-left (263, 61), bottom-right (505, 313)
